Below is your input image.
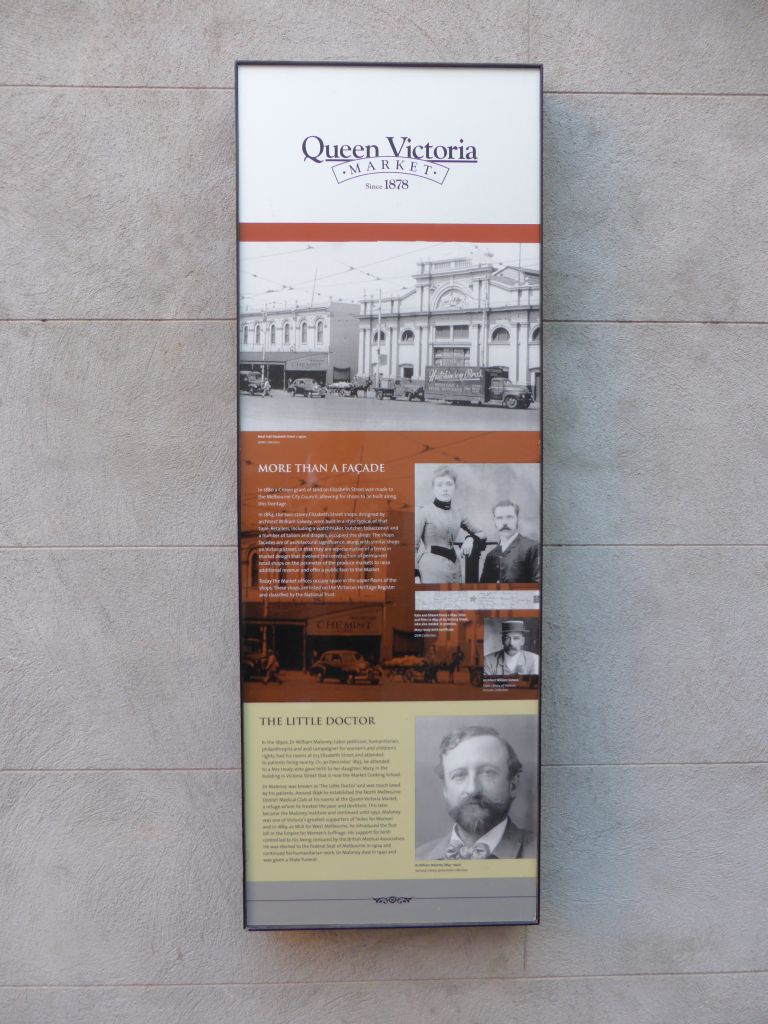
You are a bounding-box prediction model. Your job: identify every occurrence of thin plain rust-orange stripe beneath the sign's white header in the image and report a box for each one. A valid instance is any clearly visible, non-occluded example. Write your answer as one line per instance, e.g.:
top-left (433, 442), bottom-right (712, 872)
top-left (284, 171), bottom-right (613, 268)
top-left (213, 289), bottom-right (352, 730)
top-left (240, 223), bottom-right (542, 243)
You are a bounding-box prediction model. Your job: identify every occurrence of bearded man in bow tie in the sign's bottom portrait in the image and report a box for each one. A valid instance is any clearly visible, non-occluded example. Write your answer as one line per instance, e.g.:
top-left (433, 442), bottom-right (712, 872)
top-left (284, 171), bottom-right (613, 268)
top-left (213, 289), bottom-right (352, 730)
top-left (416, 725), bottom-right (537, 860)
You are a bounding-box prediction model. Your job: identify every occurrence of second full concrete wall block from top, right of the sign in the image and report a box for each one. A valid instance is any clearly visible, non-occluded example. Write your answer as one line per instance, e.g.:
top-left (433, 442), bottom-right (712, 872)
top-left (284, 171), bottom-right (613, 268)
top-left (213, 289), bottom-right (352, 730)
top-left (544, 324), bottom-right (768, 545)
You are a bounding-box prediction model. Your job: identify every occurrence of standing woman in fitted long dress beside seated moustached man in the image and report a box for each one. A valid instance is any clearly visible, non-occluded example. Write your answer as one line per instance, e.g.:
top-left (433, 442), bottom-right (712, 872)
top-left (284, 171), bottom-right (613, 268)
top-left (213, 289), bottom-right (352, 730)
top-left (416, 466), bottom-right (485, 583)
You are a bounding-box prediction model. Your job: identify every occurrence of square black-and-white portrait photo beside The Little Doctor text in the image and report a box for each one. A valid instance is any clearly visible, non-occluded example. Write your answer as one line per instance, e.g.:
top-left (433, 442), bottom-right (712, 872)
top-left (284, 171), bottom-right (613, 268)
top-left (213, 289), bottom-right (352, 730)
top-left (415, 715), bottom-right (539, 860)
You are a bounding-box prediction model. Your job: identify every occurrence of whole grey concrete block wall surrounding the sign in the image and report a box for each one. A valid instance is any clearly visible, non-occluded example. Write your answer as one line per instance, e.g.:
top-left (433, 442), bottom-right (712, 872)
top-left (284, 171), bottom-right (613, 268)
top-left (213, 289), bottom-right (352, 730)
top-left (0, 0), bottom-right (768, 1024)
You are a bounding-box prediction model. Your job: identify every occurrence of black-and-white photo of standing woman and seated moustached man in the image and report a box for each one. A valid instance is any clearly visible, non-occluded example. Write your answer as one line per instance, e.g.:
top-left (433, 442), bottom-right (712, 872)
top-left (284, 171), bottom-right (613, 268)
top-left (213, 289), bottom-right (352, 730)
top-left (415, 463), bottom-right (541, 585)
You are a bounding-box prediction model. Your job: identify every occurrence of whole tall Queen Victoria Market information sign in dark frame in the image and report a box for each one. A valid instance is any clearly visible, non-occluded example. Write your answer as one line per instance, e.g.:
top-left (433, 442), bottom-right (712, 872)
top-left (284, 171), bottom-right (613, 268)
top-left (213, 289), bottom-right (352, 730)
top-left (237, 62), bottom-right (542, 929)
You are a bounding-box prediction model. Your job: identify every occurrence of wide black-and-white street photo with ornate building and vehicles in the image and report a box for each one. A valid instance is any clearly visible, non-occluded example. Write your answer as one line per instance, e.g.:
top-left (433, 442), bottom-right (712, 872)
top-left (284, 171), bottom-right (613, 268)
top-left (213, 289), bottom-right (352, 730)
top-left (239, 242), bottom-right (542, 430)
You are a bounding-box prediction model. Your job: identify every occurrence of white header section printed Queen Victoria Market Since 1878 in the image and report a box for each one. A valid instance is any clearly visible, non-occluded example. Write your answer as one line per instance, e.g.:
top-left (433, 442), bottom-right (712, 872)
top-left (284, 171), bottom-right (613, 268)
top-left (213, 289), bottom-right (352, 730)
top-left (238, 65), bottom-right (541, 224)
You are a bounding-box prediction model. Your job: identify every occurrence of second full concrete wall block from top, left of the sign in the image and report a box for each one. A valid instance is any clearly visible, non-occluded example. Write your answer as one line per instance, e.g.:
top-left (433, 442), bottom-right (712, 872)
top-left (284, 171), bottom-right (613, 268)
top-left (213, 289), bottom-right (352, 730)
top-left (0, 322), bottom-right (237, 546)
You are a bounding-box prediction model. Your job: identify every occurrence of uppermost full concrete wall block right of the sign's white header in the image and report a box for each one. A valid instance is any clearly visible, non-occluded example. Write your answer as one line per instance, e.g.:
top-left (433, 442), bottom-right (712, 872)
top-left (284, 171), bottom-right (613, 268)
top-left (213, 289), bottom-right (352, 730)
top-left (544, 95), bottom-right (768, 322)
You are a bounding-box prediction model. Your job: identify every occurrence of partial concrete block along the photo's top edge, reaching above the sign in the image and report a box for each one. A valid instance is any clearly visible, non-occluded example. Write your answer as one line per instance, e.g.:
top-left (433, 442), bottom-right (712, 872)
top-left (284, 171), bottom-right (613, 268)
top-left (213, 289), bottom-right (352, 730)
top-left (0, 0), bottom-right (528, 88)
